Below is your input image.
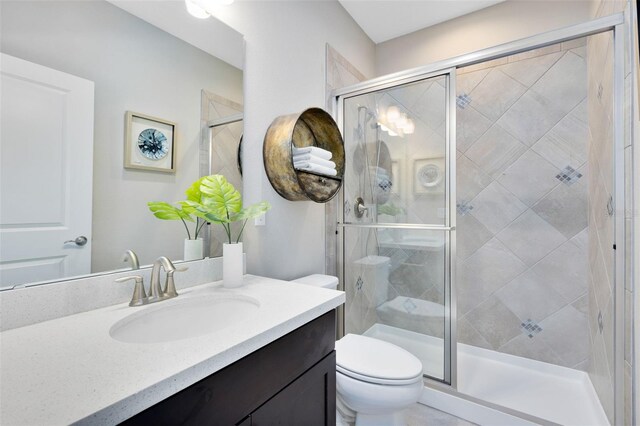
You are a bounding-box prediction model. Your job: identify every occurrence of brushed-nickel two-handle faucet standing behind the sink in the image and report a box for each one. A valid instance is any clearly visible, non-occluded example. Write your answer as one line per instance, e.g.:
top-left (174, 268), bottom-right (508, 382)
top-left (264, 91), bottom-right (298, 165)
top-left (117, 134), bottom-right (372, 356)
top-left (116, 256), bottom-right (188, 306)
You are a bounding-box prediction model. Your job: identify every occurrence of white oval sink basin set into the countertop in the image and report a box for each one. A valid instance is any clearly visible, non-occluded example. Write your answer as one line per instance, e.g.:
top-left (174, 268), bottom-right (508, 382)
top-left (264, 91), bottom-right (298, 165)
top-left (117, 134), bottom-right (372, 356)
top-left (109, 295), bottom-right (260, 343)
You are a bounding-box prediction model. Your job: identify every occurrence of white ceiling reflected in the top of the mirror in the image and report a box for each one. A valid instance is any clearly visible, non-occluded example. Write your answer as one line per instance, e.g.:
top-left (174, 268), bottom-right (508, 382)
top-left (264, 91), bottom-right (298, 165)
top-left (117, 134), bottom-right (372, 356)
top-left (107, 0), bottom-right (244, 69)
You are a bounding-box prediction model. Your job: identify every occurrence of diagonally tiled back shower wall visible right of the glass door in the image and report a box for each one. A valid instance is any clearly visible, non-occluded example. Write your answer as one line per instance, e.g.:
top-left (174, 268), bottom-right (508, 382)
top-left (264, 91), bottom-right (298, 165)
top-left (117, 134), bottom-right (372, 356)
top-left (457, 39), bottom-right (591, 370)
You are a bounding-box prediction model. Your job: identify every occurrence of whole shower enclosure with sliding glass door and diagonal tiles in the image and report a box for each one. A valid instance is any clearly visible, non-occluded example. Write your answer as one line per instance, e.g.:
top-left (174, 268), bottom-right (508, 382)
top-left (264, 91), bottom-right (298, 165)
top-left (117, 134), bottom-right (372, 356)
top-left (334, 16), bottom-right (624, 425)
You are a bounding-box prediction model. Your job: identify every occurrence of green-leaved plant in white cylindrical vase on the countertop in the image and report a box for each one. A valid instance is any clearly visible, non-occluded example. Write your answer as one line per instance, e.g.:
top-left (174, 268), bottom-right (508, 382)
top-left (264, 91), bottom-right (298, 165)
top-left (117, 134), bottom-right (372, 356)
top-left (148, 175), bottom-right (271, 287)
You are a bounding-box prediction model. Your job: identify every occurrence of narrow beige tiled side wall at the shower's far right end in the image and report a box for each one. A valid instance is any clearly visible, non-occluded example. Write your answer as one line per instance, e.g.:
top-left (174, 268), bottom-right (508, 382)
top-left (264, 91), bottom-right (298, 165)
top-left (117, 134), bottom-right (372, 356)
top-left (587, 1), bottom-right (637, 425)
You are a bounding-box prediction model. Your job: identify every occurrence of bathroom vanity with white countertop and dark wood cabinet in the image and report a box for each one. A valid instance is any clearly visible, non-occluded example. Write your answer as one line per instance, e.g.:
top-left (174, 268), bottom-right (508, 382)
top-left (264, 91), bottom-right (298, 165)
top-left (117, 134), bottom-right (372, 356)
top-left (0, 275), bottom-right (344, 426)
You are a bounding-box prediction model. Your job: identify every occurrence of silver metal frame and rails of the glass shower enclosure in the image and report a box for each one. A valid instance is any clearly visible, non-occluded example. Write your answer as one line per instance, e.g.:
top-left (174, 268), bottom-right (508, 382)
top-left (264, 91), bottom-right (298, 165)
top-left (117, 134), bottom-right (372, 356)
top-left (331, 8), bottom-right (637, 424)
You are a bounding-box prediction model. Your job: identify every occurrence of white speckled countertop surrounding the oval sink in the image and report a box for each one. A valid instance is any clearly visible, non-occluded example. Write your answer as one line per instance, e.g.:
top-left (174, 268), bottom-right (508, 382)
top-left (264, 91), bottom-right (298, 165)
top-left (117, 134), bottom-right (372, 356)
top-left (0, 275), bottom-right (345, 426)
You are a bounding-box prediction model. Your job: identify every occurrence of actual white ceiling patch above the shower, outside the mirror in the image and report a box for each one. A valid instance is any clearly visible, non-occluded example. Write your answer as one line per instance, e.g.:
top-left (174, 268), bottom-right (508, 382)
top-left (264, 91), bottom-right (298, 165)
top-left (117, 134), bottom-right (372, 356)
top-left (338, 0), bottom-right (504, 44)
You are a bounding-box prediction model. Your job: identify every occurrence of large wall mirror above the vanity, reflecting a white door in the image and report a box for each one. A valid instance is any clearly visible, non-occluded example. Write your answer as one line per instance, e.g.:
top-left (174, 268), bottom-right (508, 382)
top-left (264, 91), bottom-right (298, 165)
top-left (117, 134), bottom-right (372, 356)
top-left (0, 0), bottom-right (244, 290)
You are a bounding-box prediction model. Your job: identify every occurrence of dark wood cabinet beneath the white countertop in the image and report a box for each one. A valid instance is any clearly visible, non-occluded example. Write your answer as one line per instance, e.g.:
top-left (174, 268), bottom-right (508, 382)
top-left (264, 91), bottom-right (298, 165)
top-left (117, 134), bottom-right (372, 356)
top-left (123, 311), bottom-right (336, 426)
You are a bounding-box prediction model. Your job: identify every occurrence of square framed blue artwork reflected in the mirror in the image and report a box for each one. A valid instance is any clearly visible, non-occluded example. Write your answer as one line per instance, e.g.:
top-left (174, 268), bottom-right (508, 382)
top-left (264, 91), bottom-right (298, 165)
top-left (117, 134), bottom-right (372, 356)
top-left (124, 111), bottom-right (176, 173)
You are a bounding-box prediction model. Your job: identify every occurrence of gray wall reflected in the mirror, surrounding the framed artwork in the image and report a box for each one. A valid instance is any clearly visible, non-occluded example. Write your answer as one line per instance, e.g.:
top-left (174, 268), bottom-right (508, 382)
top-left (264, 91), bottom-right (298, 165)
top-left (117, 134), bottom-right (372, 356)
top-left (1, 1), bottom-right (243, 271)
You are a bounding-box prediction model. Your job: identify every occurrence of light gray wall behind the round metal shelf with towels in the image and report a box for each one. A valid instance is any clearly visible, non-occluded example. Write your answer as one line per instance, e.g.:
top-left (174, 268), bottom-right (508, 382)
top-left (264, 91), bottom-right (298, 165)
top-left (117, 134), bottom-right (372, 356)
top-left (212, 1), bottom-right (375, 279)
